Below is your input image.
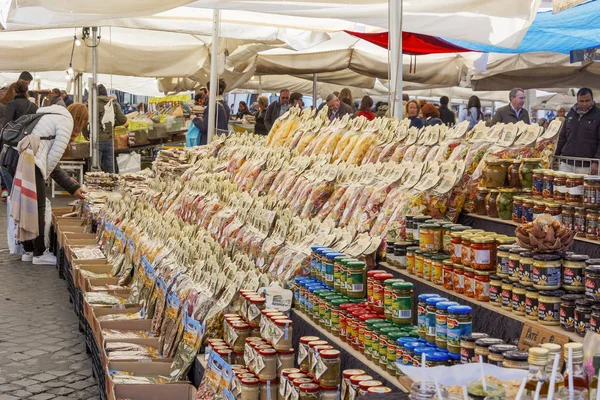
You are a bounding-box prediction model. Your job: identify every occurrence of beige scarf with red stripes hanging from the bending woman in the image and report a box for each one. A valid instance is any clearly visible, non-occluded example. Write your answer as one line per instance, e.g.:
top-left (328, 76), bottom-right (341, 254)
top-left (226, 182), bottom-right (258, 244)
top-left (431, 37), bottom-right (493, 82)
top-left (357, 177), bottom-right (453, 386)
top-left (10, 135), bottom-right (40, 242)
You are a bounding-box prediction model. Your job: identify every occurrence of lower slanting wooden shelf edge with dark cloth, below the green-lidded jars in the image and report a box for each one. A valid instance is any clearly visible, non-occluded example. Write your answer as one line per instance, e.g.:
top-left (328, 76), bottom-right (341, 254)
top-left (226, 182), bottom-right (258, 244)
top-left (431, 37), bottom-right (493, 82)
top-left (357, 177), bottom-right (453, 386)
top-left (291, 308), bottom-right (412, 395)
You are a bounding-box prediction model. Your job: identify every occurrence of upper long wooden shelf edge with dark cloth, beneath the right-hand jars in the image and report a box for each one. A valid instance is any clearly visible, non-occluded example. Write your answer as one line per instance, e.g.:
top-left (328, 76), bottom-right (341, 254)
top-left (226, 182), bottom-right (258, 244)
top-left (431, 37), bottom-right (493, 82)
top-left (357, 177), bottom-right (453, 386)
top-left (379, 262), bottom-right (583, 343)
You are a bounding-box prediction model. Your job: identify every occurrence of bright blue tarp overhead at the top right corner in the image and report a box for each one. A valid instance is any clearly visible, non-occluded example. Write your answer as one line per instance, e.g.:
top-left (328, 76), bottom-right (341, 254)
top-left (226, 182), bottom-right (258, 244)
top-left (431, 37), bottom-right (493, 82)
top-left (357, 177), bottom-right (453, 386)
top-left (445, 0), bottom-right (600, 54)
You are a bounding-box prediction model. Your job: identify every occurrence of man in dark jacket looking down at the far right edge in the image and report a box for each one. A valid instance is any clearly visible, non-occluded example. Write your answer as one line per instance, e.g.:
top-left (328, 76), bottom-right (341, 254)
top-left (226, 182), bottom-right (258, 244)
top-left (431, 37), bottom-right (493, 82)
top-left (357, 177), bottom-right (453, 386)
top-left (555, 88), bottom-right (600, 175)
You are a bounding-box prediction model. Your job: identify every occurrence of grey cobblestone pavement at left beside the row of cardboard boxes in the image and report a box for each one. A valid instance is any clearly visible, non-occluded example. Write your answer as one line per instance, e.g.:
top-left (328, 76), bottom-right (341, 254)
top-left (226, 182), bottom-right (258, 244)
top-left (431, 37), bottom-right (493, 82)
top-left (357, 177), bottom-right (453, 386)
top-left (0, 199), bottom-right (100, 400)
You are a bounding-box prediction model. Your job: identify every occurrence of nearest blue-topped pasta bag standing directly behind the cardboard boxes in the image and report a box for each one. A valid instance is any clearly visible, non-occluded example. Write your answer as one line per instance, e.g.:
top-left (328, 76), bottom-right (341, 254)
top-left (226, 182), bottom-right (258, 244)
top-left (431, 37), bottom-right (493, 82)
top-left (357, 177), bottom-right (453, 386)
top-left (170, 313), bottom-right (204, 382)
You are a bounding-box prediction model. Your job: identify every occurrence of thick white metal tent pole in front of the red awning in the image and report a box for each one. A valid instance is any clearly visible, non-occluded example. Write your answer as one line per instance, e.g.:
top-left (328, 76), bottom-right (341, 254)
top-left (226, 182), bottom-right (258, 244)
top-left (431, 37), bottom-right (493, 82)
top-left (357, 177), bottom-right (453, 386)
top-left (388, 0), bottom-right (403, 119)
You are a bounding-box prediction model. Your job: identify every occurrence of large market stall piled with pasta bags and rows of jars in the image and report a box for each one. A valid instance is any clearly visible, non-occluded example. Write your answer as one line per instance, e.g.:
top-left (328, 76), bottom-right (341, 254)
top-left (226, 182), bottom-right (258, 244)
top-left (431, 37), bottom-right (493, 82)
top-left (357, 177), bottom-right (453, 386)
top-left (48, 103), bottom-right (600, 399)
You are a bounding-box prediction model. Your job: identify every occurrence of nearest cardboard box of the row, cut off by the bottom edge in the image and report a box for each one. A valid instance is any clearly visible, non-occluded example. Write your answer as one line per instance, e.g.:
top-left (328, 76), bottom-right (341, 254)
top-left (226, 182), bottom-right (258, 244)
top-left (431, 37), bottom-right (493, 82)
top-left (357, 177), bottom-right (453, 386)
top-left (108, 383), bottom-right (196, 400)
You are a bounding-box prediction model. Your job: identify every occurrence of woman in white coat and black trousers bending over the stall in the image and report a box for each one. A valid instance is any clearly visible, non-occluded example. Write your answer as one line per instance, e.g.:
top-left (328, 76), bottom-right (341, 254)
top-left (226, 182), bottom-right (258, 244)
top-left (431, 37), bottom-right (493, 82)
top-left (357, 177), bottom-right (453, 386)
top-left (10, 104), bottom-right (87, 265)
